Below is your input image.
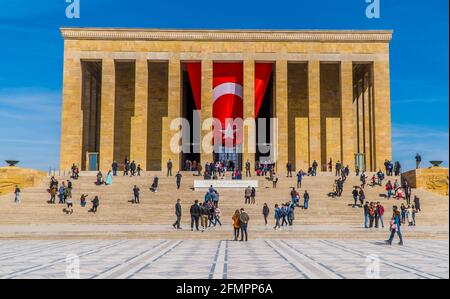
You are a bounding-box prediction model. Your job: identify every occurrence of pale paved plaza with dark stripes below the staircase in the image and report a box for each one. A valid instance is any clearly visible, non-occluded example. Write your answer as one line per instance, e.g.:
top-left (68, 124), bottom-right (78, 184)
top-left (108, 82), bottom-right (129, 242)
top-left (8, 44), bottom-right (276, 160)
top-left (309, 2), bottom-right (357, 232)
top-left (0, 239), bottom-right (449, 279)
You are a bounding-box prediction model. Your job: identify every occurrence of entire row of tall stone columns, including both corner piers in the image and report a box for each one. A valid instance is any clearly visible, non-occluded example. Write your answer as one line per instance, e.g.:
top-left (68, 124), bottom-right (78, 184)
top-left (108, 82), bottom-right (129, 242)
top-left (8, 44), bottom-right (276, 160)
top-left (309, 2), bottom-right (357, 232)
top-left (61, 57), bottom-right (392, 171)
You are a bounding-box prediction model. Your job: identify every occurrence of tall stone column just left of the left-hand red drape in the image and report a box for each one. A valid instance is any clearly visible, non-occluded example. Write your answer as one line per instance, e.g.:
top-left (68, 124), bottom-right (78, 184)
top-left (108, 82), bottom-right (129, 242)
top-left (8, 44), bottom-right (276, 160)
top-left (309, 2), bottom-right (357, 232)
top-left (161, 58), bottom-right (181, 172)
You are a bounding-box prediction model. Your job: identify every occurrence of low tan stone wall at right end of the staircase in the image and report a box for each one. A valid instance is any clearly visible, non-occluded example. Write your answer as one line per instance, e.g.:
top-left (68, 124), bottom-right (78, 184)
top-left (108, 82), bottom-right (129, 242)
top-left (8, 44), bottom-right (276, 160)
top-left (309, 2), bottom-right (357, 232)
top-left (402, 167), bottom-right (449, 195)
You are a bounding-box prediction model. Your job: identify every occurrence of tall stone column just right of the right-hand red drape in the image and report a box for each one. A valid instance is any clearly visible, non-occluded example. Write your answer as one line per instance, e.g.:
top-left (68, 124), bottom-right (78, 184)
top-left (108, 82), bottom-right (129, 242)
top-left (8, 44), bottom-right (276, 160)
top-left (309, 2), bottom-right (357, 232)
top-left (274, 60), bottom-right (289, 173)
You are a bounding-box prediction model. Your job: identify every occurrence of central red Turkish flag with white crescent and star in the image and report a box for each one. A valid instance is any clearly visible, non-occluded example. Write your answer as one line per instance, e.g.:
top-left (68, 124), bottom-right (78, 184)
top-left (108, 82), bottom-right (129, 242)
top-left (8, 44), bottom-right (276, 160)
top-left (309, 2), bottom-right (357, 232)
top-left (212, 62), bottom-right (244, 145)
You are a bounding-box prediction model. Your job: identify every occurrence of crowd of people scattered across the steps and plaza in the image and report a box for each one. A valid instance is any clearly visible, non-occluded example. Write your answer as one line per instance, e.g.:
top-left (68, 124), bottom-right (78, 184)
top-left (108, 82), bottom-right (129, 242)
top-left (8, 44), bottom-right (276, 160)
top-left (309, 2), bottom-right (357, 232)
top-left (10, 154), bottom-right (428, 244)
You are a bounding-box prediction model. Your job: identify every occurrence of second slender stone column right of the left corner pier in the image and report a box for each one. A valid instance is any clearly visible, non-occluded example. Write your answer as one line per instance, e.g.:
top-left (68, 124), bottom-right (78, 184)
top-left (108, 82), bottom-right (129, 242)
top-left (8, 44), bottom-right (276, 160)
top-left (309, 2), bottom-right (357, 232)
top-left (130, 59), bottom-right (148, 170)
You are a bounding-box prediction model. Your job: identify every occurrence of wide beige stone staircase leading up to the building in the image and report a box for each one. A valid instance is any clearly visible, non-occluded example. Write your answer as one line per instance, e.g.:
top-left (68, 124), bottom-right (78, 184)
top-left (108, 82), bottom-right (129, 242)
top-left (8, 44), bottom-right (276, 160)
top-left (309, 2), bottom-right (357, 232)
top-left (0, 172), bottom-right (449, 239)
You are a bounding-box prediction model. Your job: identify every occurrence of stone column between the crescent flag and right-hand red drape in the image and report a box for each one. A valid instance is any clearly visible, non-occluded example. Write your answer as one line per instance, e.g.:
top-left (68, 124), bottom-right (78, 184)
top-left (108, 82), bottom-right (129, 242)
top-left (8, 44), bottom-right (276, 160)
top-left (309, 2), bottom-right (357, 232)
top-left (242, 59), bottom-right (256, 170)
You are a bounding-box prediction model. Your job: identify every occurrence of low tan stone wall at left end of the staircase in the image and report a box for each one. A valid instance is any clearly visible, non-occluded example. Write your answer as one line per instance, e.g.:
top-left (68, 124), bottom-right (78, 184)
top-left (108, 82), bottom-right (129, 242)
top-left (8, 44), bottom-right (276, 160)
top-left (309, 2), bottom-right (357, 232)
top-left (0, 166), bottom-right (47, 195)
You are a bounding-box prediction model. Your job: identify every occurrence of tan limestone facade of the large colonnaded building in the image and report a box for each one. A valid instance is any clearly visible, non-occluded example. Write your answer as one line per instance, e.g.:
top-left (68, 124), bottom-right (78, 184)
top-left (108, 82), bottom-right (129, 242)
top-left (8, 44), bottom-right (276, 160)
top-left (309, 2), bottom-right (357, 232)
top-left (60, 28), bottom-right (392, 171)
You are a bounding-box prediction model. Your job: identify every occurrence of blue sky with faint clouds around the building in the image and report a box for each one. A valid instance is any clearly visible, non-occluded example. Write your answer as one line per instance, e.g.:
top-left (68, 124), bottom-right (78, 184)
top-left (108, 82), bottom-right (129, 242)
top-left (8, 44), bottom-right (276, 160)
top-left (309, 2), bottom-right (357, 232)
top-left (0, 0), bottom-right (449, 169)
